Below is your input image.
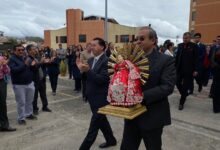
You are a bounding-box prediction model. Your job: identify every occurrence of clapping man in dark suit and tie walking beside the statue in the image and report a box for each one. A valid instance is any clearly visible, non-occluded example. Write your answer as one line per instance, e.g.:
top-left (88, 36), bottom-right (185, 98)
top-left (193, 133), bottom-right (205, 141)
top-left (78, 38), bottom-right (116, 150)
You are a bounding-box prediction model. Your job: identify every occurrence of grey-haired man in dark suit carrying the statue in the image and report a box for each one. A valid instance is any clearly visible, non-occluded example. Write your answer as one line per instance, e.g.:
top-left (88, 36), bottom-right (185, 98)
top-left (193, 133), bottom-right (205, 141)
top-left (121, 27), bottom-right (176, 150)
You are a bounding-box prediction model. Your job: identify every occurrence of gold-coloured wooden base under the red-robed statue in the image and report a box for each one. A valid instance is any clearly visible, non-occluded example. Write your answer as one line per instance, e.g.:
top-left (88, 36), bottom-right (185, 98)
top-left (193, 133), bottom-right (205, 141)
top-left (98, 104), bottom-right (147, 120)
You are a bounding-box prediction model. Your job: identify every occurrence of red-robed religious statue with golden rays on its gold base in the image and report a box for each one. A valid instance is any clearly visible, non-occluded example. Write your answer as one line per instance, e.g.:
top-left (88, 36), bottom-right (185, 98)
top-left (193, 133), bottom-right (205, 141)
top-left (98, 44), bottom-right (149, 119)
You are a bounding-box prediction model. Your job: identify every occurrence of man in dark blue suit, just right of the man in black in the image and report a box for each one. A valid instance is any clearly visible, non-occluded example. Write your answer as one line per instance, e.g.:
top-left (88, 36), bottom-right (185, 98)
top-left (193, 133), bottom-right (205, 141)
top-left (194, 33), bottom-right (206, 92)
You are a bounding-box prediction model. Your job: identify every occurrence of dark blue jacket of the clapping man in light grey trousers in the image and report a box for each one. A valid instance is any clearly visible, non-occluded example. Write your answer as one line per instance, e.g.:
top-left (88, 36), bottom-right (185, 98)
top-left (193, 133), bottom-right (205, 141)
top-left (9, 55), bottom-right (33, 85)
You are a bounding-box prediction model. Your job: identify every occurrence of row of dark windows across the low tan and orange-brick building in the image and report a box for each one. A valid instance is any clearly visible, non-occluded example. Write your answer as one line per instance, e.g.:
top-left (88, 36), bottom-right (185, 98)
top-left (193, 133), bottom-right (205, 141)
top-left (56, 34), bottom-right (135, 43)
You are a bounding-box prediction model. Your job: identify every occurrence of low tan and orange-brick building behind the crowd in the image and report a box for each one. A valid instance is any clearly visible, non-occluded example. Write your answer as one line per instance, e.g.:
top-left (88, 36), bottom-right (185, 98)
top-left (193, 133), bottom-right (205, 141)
top-left (44, 9), bottom-right (139, 49)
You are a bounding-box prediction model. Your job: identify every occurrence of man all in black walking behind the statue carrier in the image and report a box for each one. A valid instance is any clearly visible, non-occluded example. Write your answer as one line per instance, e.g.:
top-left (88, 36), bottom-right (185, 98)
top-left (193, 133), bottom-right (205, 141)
top-left (175, 32), bottom-right (198, 110)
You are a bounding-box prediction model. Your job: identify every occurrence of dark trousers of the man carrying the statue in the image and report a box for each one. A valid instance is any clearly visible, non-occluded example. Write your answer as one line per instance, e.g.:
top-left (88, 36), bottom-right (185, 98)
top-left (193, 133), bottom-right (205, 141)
top-left (120, 121), bottom-right (163, 150)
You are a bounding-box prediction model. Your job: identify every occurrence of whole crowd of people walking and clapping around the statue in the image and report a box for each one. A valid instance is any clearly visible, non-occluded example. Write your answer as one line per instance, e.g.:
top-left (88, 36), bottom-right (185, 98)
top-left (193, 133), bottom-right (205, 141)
top-left (0, 27), bottom-right (220, 150)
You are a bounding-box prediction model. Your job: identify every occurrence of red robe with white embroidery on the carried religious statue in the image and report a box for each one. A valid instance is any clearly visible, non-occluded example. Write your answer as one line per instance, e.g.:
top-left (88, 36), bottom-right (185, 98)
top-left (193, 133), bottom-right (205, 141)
top-left (107, 60), bottom-right (143, 106)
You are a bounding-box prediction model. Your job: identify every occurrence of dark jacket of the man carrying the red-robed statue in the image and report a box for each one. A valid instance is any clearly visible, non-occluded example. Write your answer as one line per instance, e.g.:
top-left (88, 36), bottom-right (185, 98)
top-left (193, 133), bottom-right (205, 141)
top-left (126, 50), bottom-right (176, 130)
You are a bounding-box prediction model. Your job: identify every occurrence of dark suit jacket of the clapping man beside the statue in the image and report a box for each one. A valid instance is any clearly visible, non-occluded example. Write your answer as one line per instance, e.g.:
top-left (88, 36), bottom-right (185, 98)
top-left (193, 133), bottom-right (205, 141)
top-left (86, 54), bottom-right (109, 112)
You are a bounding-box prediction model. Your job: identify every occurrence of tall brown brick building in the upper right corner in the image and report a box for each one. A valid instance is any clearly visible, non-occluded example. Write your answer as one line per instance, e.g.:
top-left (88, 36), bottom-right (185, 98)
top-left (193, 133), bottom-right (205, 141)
top-left (189, 0), bottom-right (220, 44)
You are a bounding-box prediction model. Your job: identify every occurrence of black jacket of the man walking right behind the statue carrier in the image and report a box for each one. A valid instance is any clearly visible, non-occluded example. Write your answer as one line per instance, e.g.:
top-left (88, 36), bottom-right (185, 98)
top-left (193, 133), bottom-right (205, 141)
top-left (175, 42), bottom-right (199, 75)
